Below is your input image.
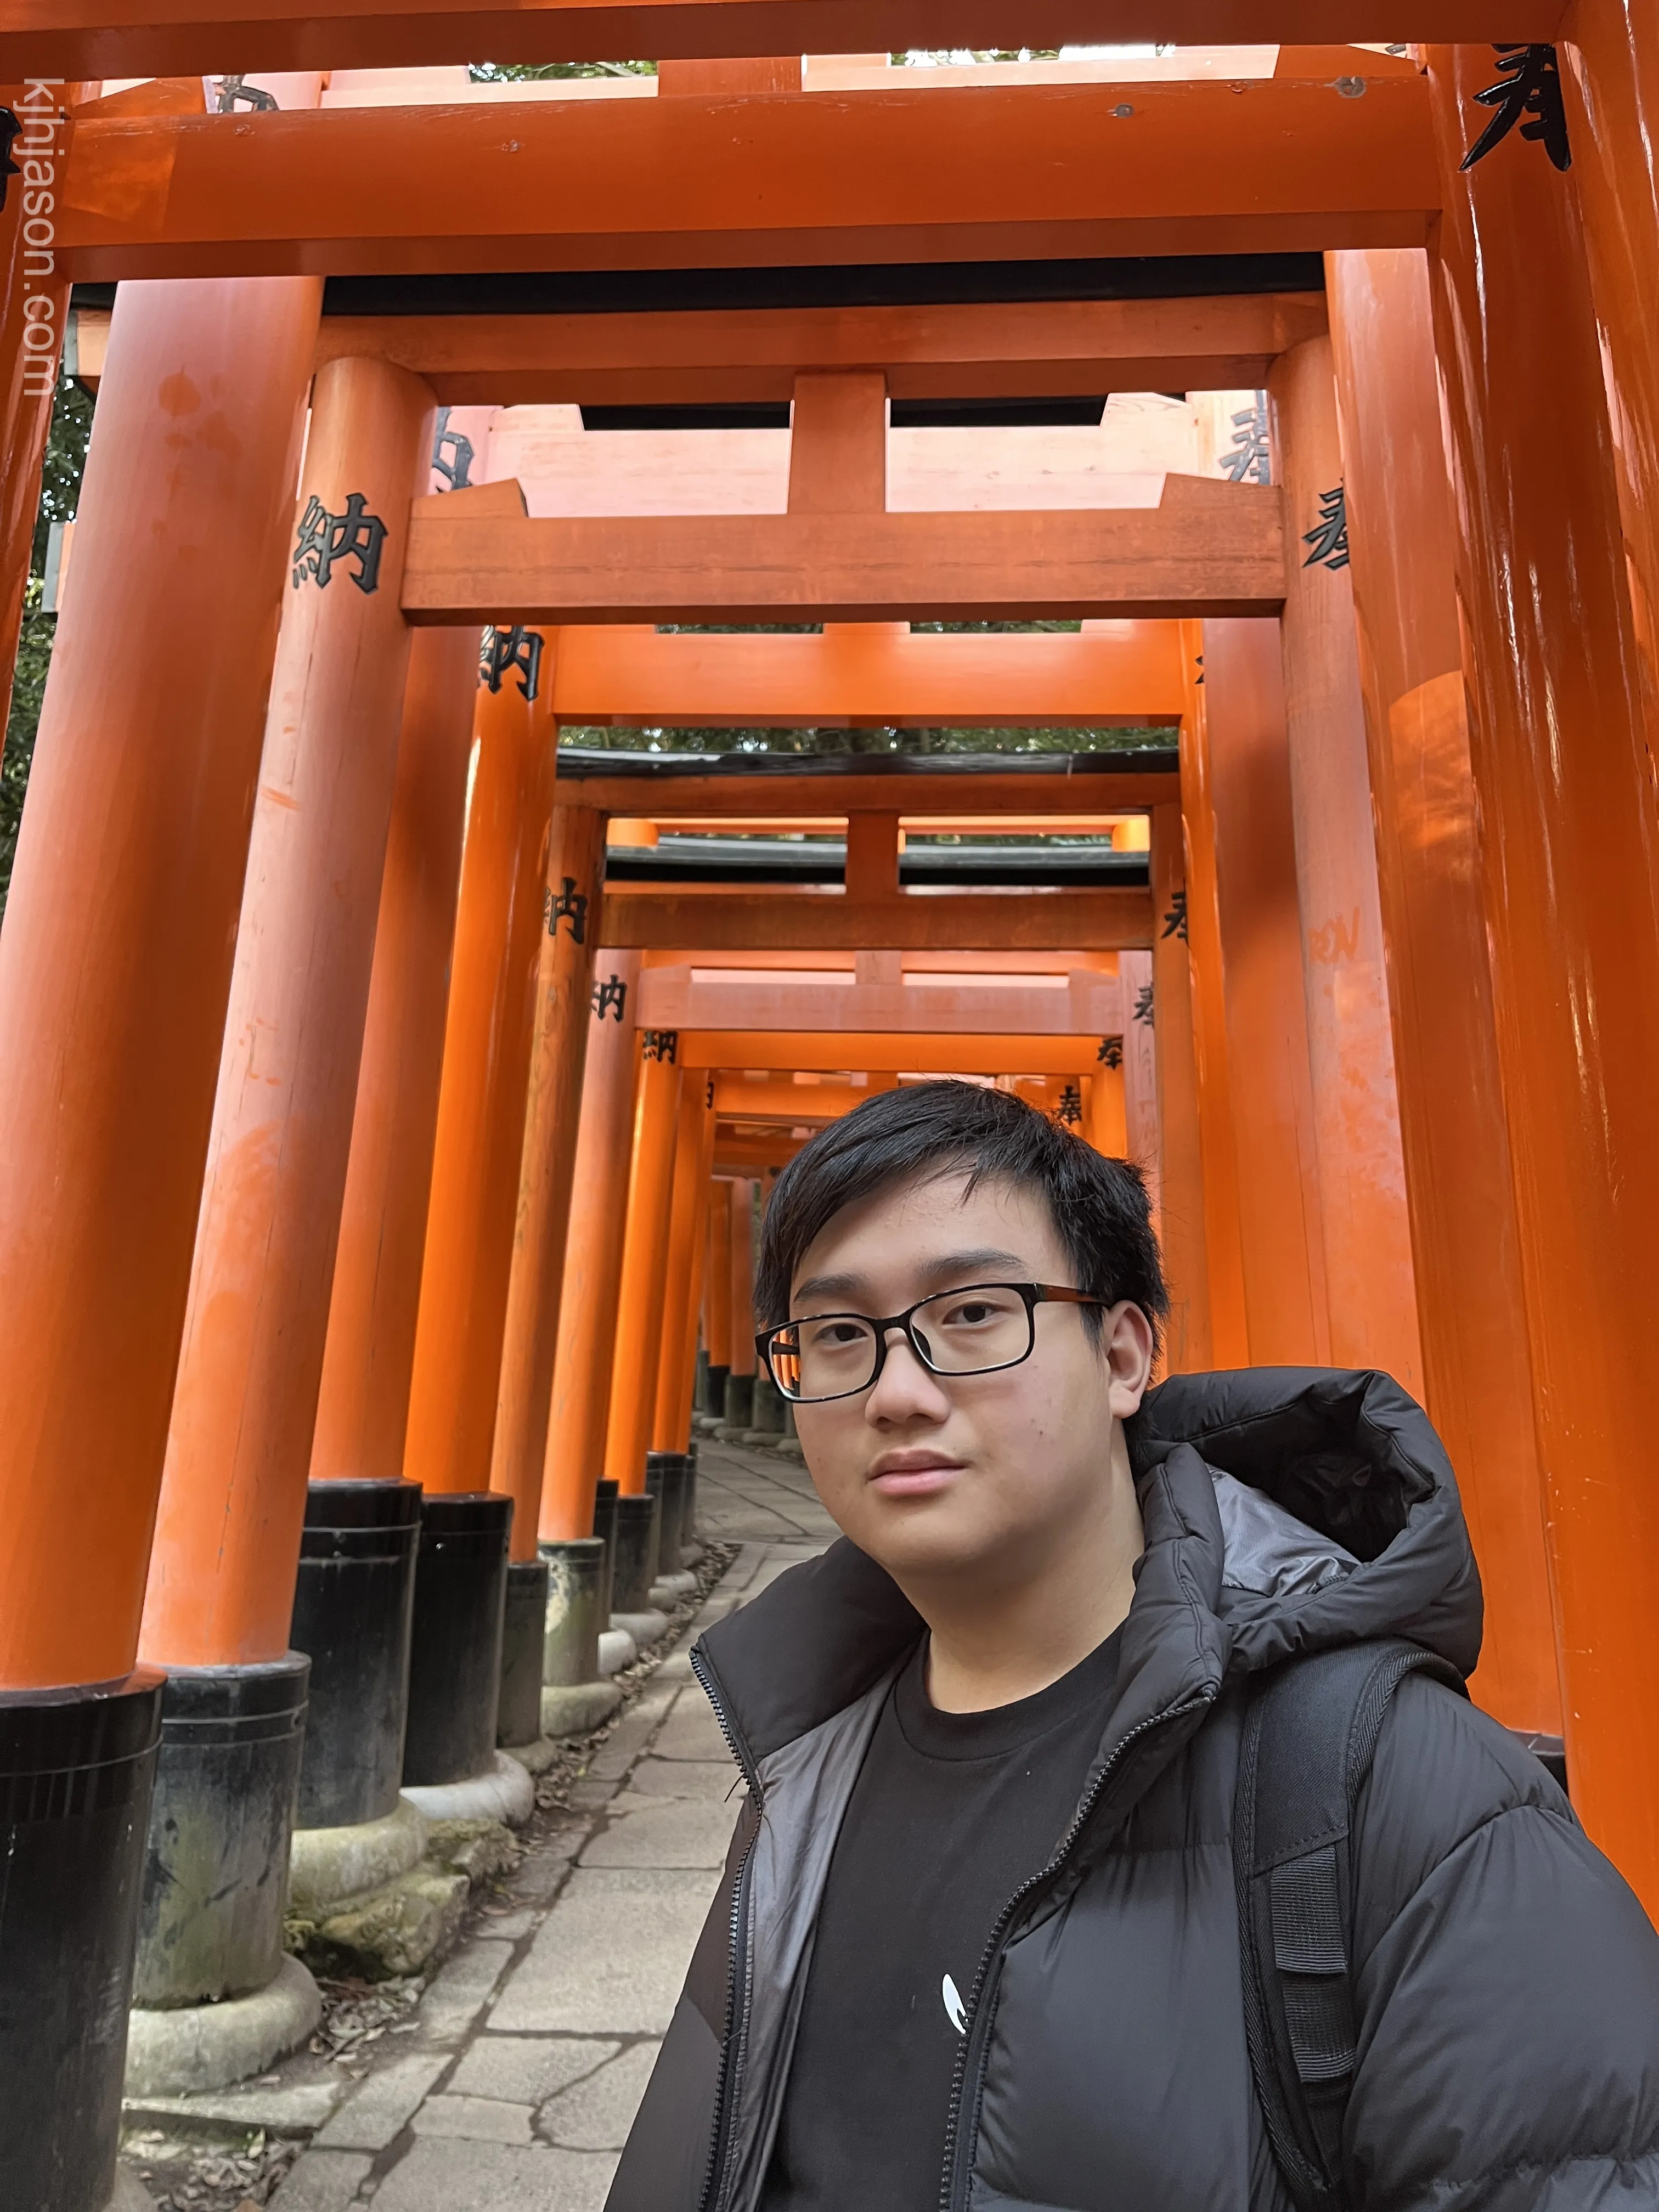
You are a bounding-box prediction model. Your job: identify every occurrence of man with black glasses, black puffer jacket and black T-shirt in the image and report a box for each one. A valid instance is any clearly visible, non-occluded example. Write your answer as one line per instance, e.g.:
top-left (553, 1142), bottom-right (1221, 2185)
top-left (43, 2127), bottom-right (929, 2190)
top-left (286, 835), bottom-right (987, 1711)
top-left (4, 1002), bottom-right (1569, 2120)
top-left (611, 1082), bottom-right (1659, 2212)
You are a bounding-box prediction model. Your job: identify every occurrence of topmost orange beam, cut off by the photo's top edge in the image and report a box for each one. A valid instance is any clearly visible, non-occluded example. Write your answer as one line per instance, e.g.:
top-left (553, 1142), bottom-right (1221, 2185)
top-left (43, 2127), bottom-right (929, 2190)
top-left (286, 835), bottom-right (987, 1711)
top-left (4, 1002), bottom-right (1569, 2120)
top-left (0, 0), bottom-right (1564, 77)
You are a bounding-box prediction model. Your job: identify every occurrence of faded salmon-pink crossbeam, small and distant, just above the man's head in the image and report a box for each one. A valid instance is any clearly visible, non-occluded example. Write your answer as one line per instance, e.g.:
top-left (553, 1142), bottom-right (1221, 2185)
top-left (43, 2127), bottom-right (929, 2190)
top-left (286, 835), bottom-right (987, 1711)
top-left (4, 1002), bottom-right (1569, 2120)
top-left (639, 967), bottom-right (1124, 1035)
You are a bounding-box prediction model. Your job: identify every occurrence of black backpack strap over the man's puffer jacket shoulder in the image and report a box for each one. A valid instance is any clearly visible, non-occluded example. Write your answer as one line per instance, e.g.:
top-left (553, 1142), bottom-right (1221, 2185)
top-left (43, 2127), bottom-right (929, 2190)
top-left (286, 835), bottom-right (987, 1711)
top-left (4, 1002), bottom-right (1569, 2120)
top-left (1232, 1641), bottom-right (1466, 2212)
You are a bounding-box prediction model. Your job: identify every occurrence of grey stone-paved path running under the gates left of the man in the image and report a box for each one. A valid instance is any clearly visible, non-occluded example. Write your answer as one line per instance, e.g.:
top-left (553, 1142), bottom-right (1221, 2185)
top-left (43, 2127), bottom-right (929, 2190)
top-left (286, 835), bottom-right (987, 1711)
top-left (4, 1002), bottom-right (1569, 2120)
top-left (250, 1444), bottom-right (834, 2212)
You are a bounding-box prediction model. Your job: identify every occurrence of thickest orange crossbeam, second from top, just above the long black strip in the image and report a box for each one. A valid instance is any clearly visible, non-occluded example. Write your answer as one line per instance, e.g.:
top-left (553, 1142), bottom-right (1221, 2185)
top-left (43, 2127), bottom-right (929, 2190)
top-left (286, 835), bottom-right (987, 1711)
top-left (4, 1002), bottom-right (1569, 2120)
top-left (58, 73), bottom-right (1440, 279)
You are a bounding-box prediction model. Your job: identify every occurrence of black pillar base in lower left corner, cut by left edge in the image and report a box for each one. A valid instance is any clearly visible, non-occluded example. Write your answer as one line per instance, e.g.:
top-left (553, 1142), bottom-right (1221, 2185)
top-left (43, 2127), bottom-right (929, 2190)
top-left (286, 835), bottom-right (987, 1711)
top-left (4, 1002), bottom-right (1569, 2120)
top-left (0, 1668), bottom-right (163, 2212)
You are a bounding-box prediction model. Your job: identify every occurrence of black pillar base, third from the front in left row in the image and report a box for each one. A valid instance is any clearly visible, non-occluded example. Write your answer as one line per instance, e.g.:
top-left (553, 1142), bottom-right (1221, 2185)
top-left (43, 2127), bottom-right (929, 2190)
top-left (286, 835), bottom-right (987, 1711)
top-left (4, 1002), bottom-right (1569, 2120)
top-left (287, 1482), bottom-right (420, 1827)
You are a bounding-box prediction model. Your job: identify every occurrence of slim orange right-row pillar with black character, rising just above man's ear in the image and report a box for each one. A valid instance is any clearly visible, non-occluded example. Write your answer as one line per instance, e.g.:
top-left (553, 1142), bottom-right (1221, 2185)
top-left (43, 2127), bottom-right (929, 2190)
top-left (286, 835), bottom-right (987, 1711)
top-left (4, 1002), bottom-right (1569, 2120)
top-left (1150, 805), bottom-right (1212, 1374)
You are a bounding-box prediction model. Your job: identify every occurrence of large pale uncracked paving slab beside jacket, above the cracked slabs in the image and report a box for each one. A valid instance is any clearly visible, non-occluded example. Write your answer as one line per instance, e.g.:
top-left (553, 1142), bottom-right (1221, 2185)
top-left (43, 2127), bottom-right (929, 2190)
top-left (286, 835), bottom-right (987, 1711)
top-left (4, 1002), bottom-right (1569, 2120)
top-left (489, 1867), bottom-right (719, 2035)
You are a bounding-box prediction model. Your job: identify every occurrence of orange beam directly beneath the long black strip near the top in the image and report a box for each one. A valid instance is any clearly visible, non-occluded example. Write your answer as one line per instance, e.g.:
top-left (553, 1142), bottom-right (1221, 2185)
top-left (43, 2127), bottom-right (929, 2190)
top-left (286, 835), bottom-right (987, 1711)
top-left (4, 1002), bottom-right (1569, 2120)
top-left (319, 292), bottom-right (1325, 407)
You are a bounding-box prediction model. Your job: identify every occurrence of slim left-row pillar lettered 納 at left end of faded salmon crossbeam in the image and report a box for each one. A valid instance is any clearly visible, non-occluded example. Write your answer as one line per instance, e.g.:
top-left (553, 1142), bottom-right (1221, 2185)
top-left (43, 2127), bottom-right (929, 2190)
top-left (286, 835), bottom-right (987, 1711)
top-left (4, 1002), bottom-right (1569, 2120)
top-left (540, 951), bottom-right (641, 1544)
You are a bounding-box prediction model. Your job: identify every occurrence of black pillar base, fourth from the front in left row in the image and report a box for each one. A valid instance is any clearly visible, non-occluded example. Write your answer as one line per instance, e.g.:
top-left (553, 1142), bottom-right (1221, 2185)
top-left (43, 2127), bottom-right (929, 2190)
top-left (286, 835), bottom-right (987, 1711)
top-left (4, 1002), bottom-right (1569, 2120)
top-left (403, 1491), bottom-right (513, 1785)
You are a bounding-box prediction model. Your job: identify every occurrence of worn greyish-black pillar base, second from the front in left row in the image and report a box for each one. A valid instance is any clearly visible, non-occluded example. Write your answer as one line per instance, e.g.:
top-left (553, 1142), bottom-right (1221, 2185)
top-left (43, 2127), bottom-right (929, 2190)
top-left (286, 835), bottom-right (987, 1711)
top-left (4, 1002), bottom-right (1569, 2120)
top-left (133, 1652), bottom-right (312, 2011)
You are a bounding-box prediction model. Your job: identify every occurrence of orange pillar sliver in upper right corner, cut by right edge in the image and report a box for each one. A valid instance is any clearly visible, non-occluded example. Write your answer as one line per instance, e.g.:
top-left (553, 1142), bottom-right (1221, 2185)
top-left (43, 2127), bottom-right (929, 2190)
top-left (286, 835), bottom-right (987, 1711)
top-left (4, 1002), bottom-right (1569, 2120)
top-left (1558, 17), bottom-right (1659, 721)
